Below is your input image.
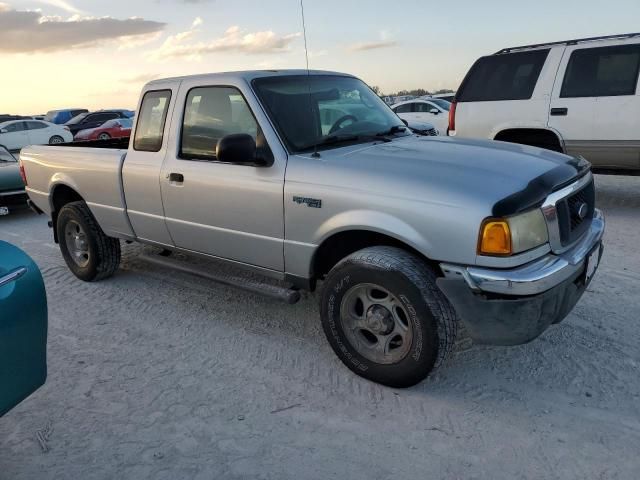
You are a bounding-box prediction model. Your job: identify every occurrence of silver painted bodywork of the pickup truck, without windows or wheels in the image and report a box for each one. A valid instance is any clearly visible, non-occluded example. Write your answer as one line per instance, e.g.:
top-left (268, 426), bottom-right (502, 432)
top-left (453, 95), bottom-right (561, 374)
top-left (21, 71), bottom-right (600, 288)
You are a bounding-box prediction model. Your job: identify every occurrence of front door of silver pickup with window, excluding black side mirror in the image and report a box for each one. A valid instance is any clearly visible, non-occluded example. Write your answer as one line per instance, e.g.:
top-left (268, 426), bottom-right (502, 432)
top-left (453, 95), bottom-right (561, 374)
top-left (160, 79), bottom-right (286, 271)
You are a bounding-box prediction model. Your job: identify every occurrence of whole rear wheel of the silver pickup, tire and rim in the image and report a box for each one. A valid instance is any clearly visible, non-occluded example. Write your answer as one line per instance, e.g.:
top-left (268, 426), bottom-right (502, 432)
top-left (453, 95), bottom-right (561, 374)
top-left (56, 202), bottom-right (120, 282)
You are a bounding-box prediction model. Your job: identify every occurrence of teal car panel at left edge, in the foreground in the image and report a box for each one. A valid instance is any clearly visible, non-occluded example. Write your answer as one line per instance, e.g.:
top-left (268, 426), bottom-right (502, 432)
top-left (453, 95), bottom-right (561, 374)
top-left (0, 241), bottom-right (48, 416)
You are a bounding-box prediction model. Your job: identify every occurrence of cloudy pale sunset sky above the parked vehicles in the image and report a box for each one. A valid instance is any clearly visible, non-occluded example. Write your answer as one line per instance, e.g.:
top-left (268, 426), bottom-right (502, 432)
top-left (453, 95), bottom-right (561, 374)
top-left (0, 0), bottom-right (640, 115)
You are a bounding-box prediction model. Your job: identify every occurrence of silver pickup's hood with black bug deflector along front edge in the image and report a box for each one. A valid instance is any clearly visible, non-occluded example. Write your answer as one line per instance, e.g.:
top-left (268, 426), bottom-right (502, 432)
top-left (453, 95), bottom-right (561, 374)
top-left (336, 136), bottom-right (590, 216)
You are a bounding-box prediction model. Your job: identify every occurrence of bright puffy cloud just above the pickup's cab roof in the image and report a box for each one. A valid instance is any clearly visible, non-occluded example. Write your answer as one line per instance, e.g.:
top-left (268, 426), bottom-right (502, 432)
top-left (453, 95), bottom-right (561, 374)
top-left (150, 17), bottom-right (300, 60)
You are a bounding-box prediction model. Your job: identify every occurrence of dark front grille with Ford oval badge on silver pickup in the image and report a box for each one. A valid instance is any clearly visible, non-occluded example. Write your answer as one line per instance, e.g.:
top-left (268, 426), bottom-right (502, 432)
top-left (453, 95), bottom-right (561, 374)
top-left (556, 179), bottom-right (596, 247)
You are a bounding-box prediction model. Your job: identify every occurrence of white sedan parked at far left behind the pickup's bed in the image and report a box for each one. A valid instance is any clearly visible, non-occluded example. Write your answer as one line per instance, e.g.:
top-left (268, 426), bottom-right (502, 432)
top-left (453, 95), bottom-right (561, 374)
top-left (0, 119), bottom-right (73, 151)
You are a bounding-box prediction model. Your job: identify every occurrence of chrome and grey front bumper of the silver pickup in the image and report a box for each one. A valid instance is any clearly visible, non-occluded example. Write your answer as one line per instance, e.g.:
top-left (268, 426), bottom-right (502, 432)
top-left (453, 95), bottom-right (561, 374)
top-left (438, 210), bottom-right (605, 345)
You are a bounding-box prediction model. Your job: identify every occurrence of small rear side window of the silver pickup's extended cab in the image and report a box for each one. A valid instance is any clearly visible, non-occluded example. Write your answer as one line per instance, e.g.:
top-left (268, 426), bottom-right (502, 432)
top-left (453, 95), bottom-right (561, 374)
top-left (133, 90), bottom-right (171, 152)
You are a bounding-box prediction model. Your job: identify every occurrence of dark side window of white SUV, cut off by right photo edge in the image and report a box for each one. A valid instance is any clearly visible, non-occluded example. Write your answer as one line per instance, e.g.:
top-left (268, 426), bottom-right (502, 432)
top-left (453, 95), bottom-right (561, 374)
top-left (560, 45), bottom-right (640, 98)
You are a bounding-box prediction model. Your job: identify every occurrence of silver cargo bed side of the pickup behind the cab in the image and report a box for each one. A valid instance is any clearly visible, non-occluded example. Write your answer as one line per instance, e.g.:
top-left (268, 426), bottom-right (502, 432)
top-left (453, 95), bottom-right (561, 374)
top-left (20, 143), bottom-right (133, 237)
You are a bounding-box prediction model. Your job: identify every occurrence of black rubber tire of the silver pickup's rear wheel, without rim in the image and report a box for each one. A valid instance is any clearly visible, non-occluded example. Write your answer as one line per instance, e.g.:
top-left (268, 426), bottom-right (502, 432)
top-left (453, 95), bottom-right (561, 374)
top-left (56, 202), bottom-right (121, 282)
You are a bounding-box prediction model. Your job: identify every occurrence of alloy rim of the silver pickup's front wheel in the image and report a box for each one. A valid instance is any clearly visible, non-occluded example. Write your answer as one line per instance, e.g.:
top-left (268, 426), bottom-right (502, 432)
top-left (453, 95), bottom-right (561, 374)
top-left (340, 283), bottom-right (414, 365)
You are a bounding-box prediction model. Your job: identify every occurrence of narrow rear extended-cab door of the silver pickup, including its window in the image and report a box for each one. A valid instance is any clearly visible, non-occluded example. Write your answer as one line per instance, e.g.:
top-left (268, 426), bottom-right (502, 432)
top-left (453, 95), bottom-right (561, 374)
top-left (122, 83), bottom-right (178, 246)
